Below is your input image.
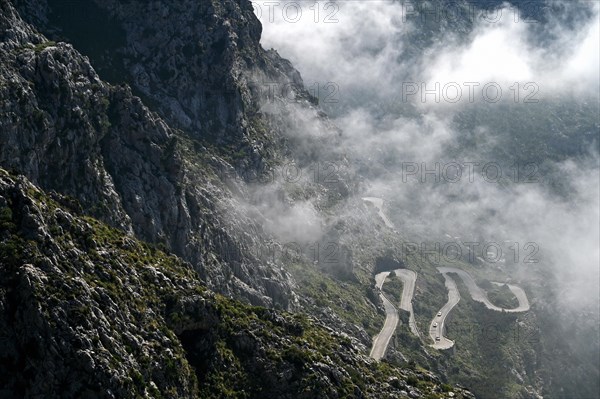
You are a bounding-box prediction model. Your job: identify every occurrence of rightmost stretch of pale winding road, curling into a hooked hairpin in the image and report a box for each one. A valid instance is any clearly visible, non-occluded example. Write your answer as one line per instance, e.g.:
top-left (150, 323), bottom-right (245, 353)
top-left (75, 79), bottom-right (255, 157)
top-left (429, 267), bottom-right (530, 349)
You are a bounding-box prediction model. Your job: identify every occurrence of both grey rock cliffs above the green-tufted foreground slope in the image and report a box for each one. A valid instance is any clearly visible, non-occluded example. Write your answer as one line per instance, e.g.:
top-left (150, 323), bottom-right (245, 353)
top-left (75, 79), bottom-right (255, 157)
top-left (0, 0), bottom-right (370, 316)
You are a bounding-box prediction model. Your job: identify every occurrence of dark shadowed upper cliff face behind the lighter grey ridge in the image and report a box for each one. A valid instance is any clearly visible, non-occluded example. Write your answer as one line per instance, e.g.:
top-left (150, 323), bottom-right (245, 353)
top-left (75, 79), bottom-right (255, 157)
top-left (19, 0), bottom-right (315, 170)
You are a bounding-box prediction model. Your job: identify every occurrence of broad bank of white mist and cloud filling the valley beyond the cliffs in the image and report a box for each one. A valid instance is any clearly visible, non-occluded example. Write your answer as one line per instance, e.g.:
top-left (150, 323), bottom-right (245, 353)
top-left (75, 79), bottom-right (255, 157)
top-left (255, 1), bottom-right (600, 396)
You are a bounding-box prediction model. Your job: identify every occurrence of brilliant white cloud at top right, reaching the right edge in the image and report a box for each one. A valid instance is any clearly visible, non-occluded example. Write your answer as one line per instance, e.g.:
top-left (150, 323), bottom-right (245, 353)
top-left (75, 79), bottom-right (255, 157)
top-left (421, 3), bottom-right (600, 106)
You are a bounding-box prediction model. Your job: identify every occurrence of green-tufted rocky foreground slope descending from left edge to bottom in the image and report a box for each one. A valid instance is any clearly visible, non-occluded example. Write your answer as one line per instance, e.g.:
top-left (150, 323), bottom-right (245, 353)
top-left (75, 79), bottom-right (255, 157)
top-left (0, 169), bottom-right (472, 399)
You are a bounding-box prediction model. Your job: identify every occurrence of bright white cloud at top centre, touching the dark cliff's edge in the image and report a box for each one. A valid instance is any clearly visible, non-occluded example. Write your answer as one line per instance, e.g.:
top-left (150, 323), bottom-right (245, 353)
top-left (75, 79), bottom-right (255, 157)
top-left (253, 1), bottom-right (405, 104)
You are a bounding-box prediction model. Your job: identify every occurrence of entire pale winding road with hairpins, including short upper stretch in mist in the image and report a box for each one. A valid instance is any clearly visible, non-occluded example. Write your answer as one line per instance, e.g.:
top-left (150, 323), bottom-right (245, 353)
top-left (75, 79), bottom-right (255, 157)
top-left (363, 197), bottom-right (530, 360)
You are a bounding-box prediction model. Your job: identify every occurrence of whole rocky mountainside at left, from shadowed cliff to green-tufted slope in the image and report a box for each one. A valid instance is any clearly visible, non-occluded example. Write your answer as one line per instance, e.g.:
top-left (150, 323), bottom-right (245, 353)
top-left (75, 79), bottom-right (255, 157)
top-left (0, 0), bottom-right (478, 398)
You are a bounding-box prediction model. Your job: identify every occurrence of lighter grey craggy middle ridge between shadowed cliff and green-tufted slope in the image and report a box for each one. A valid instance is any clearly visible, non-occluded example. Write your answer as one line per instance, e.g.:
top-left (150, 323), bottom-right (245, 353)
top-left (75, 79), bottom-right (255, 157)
top-left (0, 2), bottom-right (294, 308)
